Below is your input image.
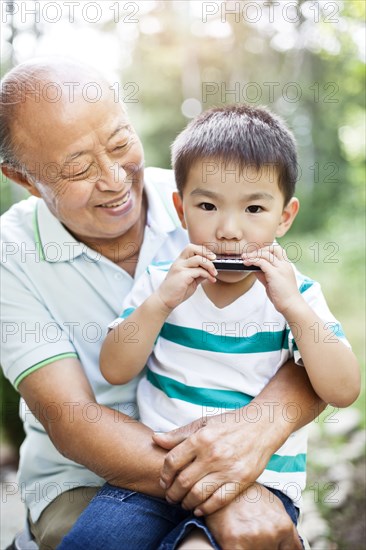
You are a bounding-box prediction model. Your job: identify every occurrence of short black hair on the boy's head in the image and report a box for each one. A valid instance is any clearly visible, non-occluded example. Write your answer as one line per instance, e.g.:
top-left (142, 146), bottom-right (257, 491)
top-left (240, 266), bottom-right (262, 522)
top-left (172, 105), bottom-right (297, 204)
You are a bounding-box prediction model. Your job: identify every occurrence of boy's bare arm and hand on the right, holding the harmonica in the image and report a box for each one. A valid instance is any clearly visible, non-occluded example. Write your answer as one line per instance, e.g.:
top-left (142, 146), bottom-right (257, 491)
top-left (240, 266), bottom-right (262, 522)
top-left (244, 245), bottom-right (360, 407)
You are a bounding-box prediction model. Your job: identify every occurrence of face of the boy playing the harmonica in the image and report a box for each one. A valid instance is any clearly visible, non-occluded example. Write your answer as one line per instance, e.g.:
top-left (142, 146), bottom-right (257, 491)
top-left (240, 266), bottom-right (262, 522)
top-left (173, 159), bottom-right (299, 282)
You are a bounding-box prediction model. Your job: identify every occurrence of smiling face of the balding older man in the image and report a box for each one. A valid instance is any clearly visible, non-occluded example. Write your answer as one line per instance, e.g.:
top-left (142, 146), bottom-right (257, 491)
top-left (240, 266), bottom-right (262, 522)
top-left (13, 90), bottom-right (143, 241)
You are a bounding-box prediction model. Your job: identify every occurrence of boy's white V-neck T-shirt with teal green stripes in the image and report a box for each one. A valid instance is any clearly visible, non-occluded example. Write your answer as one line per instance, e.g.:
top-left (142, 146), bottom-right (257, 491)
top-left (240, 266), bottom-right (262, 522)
top-left (121, 263), bottom-right (346, 505)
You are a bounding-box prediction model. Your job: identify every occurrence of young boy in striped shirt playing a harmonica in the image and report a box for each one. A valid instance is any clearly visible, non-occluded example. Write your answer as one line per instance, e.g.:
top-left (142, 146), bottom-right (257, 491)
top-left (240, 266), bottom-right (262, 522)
top-left (75, 106), bottom-right (359, 548)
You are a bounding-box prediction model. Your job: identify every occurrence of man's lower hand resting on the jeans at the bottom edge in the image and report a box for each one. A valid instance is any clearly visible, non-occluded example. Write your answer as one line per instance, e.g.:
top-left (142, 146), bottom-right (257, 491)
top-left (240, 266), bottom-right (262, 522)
top-left (205, 483), bottom-right (302, 550)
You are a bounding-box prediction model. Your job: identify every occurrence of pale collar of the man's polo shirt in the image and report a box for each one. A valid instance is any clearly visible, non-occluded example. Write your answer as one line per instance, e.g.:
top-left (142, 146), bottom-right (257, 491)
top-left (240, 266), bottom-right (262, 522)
top-left (33, 178), bottom-right (180, 263)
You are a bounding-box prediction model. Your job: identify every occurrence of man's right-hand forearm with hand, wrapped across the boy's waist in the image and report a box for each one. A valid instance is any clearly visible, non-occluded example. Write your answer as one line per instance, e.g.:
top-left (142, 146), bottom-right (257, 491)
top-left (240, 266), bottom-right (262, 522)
top-left (153, 360), bottom-right (326, 515)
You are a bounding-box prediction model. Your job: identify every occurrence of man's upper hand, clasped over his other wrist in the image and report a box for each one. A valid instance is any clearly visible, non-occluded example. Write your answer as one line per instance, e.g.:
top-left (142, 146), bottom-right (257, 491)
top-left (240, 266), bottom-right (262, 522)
top-left (153, 409), bottom-right (271, 515)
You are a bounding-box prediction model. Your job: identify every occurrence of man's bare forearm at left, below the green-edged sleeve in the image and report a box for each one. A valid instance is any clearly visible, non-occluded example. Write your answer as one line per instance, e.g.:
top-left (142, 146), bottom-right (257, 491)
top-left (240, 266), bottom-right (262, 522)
top-left (19, 359), bottom-right (166, 497)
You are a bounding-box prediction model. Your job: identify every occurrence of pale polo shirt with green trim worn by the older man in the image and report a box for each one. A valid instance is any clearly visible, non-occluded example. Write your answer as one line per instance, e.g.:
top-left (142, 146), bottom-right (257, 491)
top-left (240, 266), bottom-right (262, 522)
top-left (0, 168), bottom-right (187, 521)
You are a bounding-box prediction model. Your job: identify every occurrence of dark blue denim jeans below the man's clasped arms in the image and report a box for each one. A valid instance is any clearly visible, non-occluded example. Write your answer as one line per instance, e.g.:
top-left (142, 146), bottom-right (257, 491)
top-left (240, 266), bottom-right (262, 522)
top-left (58, 483), bottom-right (299, 550)
